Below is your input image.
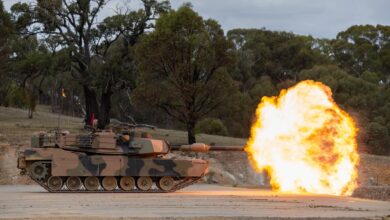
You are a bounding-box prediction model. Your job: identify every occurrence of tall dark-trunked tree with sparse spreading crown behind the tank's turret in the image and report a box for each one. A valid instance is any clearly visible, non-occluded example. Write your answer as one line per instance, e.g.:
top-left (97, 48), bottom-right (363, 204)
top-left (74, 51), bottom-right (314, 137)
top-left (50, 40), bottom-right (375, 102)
top-left (12, 0), bottom-right (169, 129)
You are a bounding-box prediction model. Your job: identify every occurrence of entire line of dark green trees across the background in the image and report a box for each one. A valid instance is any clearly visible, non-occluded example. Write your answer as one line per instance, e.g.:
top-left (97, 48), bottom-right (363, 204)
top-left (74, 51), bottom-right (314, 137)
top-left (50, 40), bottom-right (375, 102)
top-left (0, 0), bottom-right (390, 154)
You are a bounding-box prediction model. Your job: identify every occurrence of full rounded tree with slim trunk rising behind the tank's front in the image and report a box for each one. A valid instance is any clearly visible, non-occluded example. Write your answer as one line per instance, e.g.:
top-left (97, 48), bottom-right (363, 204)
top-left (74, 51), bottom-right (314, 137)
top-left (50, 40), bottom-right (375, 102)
top-left (135, 5), bottom-right (233, 143)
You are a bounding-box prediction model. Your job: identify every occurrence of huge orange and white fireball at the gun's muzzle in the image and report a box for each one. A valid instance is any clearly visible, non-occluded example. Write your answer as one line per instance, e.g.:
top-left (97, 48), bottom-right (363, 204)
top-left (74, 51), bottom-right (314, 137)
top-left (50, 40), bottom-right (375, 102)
top-left (245, 80), bottom-right (359, 195)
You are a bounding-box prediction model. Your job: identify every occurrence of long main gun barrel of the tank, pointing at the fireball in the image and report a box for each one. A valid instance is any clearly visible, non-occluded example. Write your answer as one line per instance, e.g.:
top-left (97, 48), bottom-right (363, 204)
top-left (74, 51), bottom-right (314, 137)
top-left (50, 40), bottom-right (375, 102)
top-left (171, 143), bottom-right (245, 152)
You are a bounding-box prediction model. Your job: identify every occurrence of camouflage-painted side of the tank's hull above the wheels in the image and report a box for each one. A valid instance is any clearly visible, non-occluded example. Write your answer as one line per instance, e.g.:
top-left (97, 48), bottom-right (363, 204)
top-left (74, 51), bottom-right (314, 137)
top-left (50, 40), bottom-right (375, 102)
top-left (20, 142), bottom-right (208, 177)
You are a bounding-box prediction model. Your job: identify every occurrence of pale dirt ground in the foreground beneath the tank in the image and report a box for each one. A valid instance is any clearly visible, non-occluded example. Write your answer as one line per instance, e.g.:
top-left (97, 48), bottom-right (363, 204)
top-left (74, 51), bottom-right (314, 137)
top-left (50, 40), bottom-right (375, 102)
top-left (0, 184), bottom-right (390, 219)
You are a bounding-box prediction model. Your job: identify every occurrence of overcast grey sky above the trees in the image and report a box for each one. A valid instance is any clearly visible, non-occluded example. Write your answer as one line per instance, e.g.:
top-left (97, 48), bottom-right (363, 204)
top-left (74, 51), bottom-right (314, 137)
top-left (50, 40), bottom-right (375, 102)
top-left (4, 0), bottom-right (390, 38)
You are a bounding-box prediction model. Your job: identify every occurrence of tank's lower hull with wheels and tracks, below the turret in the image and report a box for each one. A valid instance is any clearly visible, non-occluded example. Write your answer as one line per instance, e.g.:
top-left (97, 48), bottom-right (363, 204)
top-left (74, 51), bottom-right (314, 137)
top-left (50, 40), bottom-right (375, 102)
top-left (18, 147), bottom-right (208, 192)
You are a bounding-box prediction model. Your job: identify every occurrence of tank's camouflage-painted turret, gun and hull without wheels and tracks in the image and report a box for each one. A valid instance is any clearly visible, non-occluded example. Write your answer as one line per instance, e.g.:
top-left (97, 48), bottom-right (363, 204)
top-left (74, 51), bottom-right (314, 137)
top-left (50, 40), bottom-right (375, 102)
top-left (18, 132), bottom-right (243, 189)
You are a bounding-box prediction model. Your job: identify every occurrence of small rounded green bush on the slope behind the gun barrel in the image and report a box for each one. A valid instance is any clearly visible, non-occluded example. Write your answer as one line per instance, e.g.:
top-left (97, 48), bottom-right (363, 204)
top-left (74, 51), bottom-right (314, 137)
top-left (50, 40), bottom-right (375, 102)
top-left (195, 118), bottom-right (228, 136)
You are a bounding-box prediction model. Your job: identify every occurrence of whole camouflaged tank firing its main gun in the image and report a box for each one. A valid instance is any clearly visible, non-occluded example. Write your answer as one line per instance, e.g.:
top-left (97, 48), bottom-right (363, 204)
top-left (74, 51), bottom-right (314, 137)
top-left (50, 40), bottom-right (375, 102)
top-left (18, 127), bottom-right (243, 192)
